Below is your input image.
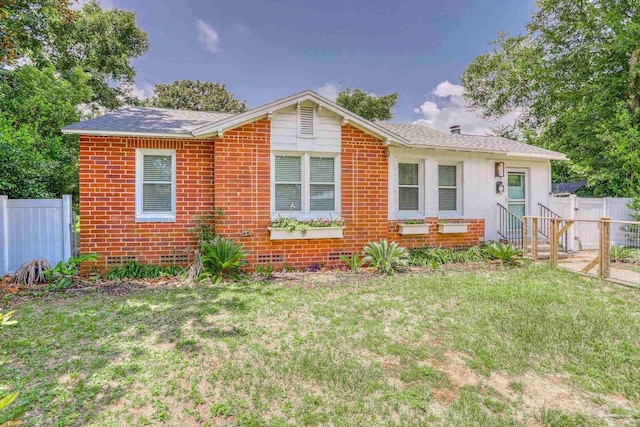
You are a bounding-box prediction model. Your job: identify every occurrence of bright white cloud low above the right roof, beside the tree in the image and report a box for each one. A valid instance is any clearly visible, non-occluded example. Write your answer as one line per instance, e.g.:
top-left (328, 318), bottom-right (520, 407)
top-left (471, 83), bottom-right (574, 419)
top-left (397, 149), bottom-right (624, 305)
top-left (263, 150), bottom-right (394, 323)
top-left (414, 80), bottom-right (519, 135)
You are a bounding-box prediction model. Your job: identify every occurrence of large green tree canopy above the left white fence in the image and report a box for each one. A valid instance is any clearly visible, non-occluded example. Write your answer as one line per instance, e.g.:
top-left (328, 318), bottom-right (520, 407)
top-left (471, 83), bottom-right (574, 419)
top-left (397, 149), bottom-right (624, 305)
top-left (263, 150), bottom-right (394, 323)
top-left (0, 0), bottom-right (148, 198)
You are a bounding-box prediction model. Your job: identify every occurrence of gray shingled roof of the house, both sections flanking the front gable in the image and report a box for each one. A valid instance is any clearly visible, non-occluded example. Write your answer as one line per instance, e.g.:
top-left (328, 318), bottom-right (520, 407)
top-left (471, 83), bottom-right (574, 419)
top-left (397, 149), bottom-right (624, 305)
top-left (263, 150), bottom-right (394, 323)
top-left (63, 107), bottom-right (565, 159)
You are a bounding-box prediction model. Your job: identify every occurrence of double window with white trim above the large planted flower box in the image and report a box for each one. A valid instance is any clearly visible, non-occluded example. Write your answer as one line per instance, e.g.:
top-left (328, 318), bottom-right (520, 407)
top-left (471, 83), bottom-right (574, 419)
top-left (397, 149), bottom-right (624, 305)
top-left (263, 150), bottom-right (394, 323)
top-left (272, 153), bottom-right (340, 217)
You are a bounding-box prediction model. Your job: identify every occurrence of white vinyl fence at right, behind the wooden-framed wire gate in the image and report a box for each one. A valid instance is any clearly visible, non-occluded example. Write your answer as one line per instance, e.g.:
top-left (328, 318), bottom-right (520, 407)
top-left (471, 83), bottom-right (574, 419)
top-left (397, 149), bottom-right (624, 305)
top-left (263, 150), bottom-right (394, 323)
top-left (549, 195), bottom-right (633, 251)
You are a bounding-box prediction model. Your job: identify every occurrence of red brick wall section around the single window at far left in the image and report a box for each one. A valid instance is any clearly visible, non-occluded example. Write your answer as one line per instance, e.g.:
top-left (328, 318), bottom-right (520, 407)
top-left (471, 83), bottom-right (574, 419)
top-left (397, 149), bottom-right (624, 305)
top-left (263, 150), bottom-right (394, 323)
top-left (80, 135), bottom-right (213, 267)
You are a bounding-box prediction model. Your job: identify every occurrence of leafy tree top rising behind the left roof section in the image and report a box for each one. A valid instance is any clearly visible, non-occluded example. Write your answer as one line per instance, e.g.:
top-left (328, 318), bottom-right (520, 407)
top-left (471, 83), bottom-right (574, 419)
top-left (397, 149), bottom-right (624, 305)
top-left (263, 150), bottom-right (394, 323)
top-left (147, 80), bottom-right (247, 113)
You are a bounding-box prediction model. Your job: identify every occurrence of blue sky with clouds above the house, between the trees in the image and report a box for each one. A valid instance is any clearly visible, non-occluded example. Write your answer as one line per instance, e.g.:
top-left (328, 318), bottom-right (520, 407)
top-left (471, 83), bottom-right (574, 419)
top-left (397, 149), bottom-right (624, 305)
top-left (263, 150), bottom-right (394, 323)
top-left (95, 0), bottom-right (534, 133)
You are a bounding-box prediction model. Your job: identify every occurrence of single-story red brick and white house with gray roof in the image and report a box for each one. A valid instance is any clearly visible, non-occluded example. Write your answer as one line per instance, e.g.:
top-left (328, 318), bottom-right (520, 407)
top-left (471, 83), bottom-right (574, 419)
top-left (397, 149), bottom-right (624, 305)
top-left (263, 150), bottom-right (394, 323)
top-left (63, 91), bottom-right (565, 268)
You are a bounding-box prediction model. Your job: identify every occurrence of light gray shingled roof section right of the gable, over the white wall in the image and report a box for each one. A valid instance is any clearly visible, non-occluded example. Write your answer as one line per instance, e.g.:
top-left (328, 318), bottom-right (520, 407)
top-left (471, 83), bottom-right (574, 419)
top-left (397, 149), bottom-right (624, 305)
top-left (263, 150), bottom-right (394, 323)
top-left (380, 123), bottom-right (565, 159)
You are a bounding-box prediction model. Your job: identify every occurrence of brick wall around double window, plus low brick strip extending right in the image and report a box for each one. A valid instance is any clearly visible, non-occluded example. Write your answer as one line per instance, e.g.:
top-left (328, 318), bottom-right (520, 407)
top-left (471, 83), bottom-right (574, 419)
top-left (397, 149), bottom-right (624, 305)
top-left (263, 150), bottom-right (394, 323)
top-left (214, 120), bottom-right (484, 267)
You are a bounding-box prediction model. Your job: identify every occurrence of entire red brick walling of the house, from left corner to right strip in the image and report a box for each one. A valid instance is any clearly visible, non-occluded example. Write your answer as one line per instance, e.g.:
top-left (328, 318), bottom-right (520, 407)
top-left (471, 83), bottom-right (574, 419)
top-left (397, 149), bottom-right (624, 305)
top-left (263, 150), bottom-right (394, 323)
top-left (80, 120), bottom-right (484, 267)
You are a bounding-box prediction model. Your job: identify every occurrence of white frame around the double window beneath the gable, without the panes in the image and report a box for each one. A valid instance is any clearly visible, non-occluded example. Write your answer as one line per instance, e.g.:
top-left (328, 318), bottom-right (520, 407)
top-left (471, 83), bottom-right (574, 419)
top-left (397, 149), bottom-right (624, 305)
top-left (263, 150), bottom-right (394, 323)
top-left (271, 151), bottom-right (342, 220)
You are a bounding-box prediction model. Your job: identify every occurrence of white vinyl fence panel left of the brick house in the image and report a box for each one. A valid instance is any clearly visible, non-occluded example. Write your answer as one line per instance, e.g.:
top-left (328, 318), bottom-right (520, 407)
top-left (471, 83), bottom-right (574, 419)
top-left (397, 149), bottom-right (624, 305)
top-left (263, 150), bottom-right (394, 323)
top-left (0, 196), bottom-right (73, 276)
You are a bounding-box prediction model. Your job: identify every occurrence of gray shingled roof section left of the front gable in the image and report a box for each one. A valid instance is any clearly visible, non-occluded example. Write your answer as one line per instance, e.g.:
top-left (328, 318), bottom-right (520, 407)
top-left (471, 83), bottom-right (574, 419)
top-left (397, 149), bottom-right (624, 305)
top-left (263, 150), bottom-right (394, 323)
top-left (63, 107), bottom-right (233, 136)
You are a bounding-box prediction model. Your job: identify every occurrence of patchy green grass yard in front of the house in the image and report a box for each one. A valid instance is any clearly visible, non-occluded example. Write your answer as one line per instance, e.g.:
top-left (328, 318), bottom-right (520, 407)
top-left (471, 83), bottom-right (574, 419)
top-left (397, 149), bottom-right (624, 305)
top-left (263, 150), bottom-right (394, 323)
top-left (0, 266), bottom-right (640, 427)
